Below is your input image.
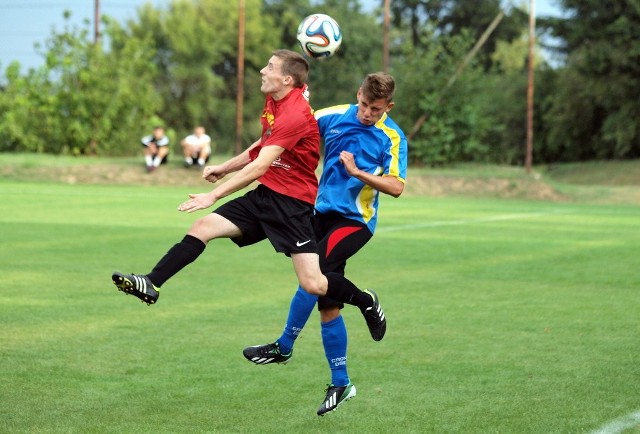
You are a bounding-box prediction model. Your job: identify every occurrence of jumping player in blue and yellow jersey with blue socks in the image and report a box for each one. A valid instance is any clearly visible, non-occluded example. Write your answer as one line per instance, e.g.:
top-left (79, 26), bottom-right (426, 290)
top-left (243, 73), bottom-right (407, 416)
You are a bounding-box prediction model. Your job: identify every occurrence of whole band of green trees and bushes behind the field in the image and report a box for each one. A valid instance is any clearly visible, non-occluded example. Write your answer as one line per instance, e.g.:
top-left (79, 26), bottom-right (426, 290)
top-left (0, 0), bottom-right (640, 165)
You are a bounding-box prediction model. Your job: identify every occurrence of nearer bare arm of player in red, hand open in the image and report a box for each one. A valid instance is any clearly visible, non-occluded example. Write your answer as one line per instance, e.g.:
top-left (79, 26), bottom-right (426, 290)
top-left (178, 145), bottom-right (284, 213)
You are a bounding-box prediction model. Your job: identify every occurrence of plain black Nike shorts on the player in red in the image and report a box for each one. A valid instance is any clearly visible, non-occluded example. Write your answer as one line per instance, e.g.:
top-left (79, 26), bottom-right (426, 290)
top-left (213, 184), bottom-right (318, 255)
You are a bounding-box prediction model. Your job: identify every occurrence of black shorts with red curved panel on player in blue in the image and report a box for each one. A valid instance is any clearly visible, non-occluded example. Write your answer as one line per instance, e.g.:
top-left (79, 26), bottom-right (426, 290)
top-left (313, 212), bottom-right (373, 310)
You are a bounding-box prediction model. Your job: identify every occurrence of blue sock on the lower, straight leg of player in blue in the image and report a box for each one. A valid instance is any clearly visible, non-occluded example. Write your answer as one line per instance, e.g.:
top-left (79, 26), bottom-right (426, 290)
top-left (321, 315), bottom-right (349, 386)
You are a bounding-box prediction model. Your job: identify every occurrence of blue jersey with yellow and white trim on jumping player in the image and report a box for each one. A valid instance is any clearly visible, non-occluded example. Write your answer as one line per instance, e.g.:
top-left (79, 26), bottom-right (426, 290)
top-left (315, 104), bottom-right (407, 233)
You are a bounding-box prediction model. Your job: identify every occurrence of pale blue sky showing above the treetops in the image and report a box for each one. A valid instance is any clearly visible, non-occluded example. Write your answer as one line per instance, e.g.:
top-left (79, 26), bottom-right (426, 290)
top-left (0, 0), bottom-right (559, 72)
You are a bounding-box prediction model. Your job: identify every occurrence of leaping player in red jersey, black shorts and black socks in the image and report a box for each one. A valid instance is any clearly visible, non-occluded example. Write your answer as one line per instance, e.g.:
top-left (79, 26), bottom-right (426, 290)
top-left (112, 50), bottom-right (386, 346)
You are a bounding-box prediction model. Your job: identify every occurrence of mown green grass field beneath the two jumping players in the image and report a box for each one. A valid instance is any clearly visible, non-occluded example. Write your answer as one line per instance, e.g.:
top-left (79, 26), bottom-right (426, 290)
top-left (0, 161), bottom-right (640, 433)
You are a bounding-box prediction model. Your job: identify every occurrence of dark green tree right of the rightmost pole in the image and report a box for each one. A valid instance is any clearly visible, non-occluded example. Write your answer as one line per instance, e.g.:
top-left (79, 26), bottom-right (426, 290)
top-left (548, 0), bottom-right (640, 161)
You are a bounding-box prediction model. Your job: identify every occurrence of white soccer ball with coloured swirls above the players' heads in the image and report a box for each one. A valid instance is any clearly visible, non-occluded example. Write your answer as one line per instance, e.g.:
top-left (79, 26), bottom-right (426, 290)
top-left (297, 14), bottom-right (342, 59)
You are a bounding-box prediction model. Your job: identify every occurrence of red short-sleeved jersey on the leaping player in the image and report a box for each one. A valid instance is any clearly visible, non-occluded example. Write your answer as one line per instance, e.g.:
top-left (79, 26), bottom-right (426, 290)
top-left (249, 85), bottom-right (320, 205)
